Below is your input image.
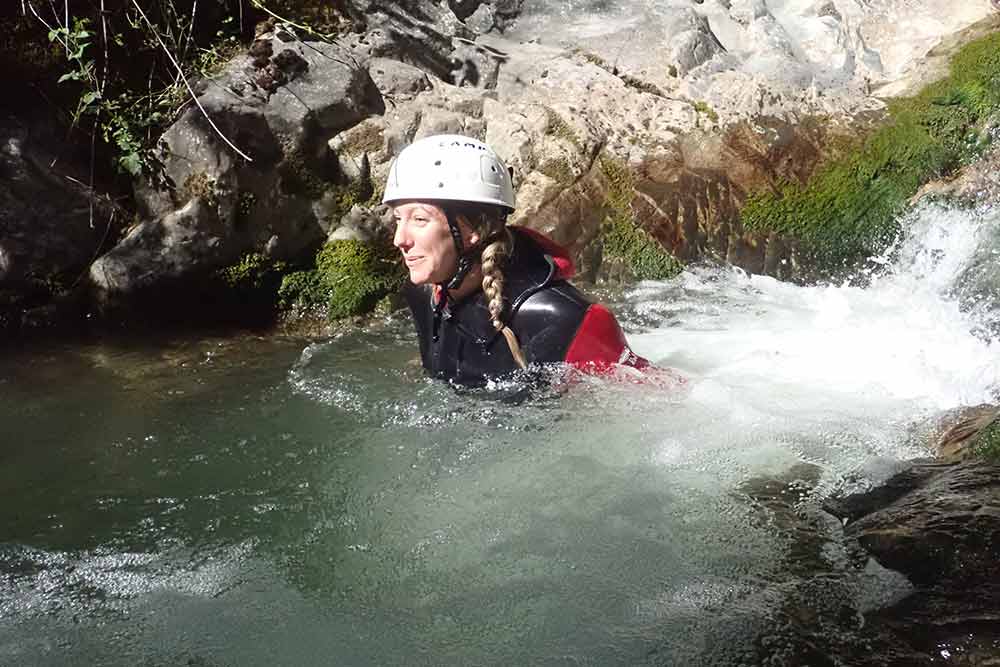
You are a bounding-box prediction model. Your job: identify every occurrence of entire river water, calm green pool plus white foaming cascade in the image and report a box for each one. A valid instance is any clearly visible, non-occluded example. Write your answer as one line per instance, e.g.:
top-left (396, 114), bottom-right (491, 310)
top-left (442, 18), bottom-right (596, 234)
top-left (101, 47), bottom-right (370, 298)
top-left (0, 201), bottom-right (1000, 665)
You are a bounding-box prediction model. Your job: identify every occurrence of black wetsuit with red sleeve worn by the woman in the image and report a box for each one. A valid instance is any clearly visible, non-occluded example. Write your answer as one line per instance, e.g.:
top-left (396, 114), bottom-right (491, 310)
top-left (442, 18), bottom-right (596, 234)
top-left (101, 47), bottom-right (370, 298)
top-left (405, 228), bottom-right (646, 386)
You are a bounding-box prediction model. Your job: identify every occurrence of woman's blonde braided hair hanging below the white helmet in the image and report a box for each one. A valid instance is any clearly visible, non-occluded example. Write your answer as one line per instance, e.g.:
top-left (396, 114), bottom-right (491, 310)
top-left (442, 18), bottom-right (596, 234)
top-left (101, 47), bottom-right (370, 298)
top-left (445, 202), bottom-right (528, 368)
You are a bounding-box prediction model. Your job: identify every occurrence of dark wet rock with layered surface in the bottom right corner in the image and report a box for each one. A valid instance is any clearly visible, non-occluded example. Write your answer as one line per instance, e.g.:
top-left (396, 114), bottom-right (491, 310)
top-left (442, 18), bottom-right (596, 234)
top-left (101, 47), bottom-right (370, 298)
top-left (827, 436), bottom-right (1000, 666)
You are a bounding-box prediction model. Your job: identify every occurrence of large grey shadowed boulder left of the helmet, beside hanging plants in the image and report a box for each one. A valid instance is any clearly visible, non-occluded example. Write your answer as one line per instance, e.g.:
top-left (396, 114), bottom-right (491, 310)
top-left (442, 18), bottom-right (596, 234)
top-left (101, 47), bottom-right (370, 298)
top-left (90, 31), bottom-right (384, 299)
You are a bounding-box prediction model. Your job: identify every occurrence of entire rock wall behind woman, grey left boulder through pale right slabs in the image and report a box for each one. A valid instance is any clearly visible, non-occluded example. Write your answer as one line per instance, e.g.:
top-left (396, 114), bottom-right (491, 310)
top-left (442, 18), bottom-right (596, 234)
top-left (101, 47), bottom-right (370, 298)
top-left (72, 0), bottom-right (993, 316)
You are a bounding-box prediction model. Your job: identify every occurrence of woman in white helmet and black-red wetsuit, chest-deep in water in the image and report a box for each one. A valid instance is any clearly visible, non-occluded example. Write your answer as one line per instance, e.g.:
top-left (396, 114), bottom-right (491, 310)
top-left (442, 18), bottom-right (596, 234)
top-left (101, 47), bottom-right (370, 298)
top-left (382, 135), bottom-right (649, 386)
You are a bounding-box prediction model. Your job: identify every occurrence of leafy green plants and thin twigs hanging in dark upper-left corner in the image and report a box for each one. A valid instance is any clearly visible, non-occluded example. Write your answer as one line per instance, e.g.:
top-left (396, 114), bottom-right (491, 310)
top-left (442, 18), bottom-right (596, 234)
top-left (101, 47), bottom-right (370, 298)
top-left (6, 0), bottom-right (348, 177)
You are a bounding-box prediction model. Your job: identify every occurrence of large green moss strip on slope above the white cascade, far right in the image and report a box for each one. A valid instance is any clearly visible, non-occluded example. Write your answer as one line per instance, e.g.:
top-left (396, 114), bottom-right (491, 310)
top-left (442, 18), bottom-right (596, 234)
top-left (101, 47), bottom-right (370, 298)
top-left (741, 33), bottom-right (1000, 266)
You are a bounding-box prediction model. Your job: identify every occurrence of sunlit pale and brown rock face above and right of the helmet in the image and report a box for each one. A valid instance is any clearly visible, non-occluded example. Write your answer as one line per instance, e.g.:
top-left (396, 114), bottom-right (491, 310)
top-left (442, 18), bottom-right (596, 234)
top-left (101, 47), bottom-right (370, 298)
top-left (322, 0), bottom-right (992, 284)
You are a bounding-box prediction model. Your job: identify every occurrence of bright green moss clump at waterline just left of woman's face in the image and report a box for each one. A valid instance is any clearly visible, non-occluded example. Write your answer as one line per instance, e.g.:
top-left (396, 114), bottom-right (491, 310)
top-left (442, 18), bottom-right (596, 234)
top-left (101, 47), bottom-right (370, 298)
top-left (278, 240), bottom-right (403, 320)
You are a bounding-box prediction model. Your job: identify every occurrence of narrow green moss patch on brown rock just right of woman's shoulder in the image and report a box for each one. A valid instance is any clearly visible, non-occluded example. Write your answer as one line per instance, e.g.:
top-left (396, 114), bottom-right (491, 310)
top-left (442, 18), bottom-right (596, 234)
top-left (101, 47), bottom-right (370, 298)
top-left (599, 155), bottom-right (683, 280)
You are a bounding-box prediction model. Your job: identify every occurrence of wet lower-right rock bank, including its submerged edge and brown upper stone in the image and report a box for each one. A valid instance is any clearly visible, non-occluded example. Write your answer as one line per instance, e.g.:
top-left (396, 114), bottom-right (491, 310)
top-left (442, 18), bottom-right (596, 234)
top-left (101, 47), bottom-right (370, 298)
top-left (738, 406), bottom-right (1000, 667)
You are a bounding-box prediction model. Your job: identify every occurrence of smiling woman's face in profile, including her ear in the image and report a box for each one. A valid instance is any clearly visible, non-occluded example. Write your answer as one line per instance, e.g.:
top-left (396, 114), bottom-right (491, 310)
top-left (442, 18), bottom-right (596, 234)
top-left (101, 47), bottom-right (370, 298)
top-left (392, 202), bottom-right (479, 285)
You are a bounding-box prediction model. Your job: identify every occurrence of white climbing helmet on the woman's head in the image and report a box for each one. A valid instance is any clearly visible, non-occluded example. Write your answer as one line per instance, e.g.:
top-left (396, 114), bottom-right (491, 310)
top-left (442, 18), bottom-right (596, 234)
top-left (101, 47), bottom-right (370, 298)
top-left (382, 134), bottom-right (514, 211)
